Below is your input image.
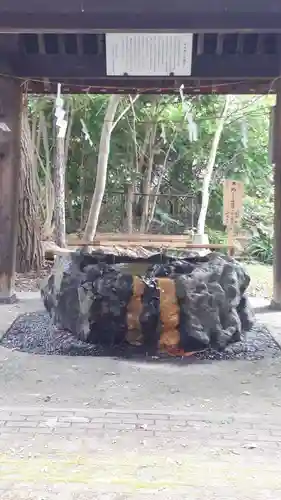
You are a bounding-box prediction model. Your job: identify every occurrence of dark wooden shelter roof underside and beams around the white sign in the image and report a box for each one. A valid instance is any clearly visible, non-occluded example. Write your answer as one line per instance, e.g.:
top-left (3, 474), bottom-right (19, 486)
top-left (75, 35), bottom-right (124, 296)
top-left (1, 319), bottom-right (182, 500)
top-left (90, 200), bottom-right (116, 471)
top-left (0, 0), bottom-right (281, 93)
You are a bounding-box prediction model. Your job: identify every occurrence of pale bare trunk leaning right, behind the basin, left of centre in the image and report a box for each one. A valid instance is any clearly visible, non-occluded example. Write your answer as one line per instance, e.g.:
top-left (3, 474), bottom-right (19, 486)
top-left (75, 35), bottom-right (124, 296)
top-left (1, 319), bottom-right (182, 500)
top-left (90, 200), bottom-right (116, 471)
top-left (84, 95), bottom-right (121, 242)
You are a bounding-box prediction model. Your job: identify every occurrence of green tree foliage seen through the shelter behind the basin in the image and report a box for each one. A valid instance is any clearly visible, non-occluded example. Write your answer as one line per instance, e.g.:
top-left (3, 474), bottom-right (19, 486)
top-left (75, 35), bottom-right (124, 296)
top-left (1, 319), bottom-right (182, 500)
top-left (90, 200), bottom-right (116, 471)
top-left (29, 95), bottom-right (272, 237)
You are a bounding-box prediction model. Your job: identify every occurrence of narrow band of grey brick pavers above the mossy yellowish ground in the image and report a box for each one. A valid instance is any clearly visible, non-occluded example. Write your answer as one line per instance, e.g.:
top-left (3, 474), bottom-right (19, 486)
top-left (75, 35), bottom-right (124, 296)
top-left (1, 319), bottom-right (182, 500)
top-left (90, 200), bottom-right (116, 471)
top-left (0, 407), bottom-right (281, 446)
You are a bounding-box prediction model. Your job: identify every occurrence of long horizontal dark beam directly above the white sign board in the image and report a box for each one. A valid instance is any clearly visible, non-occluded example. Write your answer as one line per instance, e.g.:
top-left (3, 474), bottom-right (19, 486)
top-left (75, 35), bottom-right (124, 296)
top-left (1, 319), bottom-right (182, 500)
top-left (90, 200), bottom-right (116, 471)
top-left (0, 11), bottom-right (281, 33)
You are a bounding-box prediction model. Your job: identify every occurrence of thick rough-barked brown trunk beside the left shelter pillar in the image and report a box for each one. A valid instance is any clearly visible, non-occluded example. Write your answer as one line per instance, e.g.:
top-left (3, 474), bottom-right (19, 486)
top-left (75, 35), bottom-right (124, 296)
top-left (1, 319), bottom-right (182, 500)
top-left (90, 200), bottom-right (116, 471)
top-left (16, 102), bottom-right (43, 273)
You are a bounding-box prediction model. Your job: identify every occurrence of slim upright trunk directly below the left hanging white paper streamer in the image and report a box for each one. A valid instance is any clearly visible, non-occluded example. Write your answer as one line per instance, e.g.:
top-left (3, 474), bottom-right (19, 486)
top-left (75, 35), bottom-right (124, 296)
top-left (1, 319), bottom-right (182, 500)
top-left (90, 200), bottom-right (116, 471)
top-left (54, 137), bottom-right (66, 248)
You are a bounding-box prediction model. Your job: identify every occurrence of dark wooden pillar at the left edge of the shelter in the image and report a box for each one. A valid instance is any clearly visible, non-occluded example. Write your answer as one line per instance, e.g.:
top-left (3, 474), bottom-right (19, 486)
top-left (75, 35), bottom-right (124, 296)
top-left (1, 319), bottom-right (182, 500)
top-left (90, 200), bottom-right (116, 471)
top-left (0, 77), bottom-right (22, 304)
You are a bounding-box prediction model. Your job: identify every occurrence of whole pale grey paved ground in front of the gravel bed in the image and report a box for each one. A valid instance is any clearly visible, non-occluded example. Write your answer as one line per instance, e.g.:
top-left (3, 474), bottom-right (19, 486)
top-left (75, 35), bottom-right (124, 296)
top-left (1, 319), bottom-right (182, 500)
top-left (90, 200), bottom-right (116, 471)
top-left (0, 292), bottom-right (281, 500)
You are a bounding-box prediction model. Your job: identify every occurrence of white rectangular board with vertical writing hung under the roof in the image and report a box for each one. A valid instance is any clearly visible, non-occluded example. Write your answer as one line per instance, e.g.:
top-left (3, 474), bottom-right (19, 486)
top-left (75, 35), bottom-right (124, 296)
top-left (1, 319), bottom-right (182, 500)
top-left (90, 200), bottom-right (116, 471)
top-left (105, 33), bottom-right (193, 76)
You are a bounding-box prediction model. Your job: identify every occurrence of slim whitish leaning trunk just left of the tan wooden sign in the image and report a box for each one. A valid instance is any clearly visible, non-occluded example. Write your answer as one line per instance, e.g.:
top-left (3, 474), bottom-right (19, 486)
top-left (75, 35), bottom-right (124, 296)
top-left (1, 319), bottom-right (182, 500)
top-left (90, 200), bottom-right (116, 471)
top-left (197, 95), bottom-right (230, 235)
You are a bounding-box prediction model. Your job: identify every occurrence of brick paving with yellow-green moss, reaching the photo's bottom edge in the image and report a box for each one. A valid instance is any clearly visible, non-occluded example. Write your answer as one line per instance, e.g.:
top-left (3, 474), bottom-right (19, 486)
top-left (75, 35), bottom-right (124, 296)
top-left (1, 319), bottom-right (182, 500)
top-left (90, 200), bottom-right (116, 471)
top-left (0, 407), bottom-right (281, 500)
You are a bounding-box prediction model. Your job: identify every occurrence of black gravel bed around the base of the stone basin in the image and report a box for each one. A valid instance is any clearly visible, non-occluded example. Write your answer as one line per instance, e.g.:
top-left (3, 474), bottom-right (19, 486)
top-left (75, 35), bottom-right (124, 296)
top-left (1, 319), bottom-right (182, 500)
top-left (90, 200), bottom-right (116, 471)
top-left (1, 312), bottom-right (281, 362)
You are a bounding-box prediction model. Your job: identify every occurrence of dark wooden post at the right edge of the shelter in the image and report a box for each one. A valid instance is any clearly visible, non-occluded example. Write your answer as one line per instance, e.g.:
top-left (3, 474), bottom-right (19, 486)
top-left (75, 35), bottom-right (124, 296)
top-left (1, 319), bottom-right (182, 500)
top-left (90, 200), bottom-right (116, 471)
top-left (271, 85), bottom-right (281, 309)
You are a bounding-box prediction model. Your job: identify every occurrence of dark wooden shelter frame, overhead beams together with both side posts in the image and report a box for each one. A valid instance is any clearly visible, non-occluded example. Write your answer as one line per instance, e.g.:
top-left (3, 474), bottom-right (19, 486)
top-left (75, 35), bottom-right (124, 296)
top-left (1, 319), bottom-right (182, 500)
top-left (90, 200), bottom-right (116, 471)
top-left (0, 0), bottom-right (281, 307)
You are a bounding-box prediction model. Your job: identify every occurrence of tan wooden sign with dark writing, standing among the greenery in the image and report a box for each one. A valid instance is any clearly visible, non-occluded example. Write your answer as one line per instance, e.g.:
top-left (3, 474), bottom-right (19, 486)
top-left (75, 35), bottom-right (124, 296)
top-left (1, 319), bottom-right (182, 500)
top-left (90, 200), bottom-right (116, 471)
top-left (223, 179), bottom-right (244, 228)
